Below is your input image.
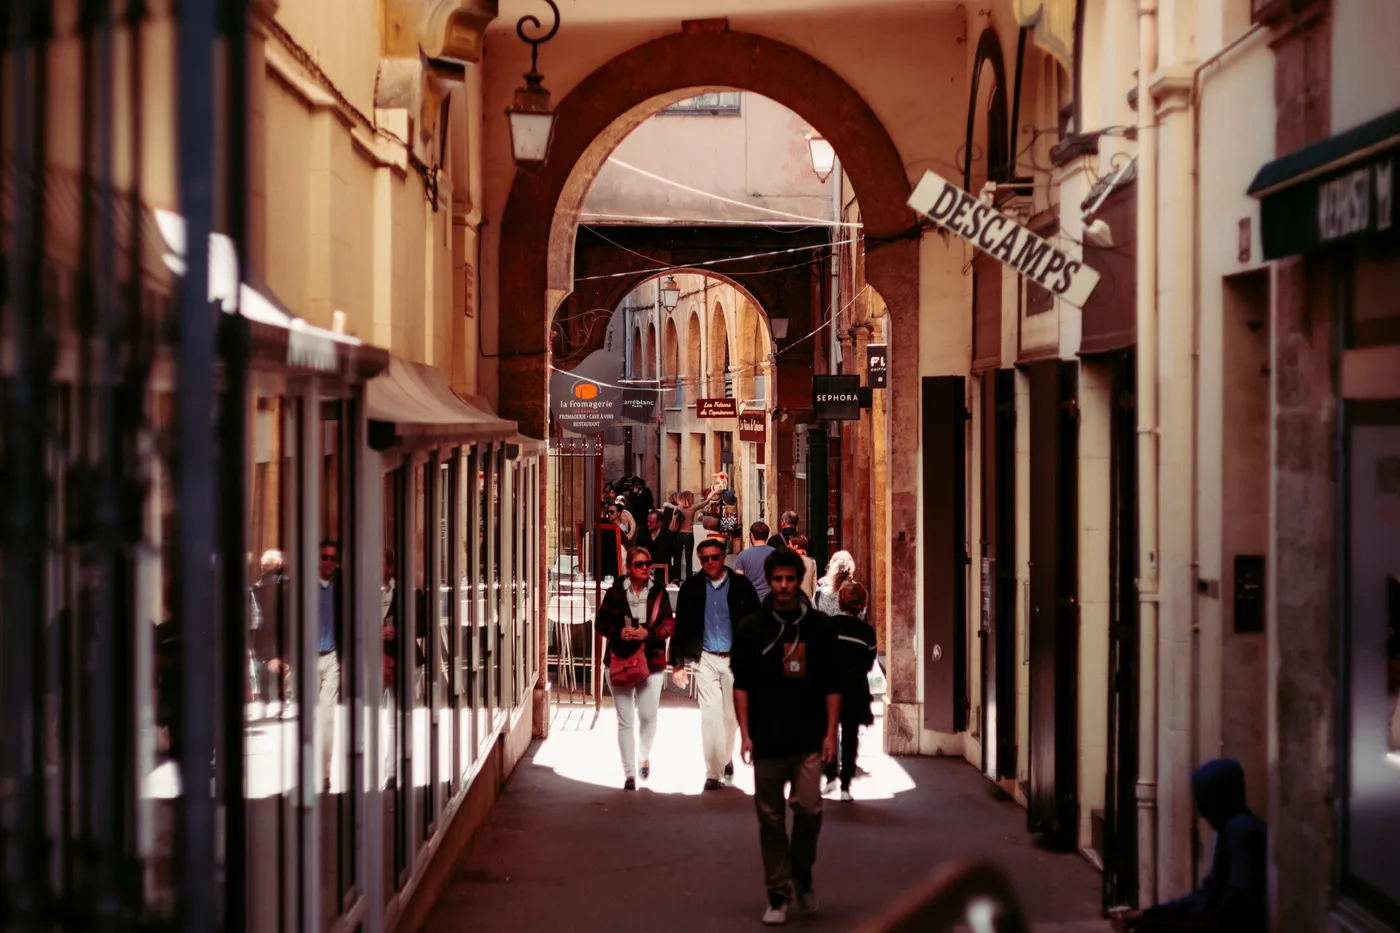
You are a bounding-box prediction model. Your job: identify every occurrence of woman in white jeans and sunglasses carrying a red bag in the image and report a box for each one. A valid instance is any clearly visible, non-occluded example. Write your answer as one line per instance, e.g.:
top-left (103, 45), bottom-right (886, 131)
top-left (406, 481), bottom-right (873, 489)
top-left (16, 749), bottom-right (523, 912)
top-left (596, 548), bottom-right (675, 790)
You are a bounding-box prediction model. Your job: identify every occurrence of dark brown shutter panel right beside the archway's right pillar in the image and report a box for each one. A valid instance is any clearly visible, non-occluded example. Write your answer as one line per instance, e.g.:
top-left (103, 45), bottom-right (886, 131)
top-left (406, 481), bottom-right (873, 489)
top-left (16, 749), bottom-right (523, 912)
top-left (921, 375), bottom-right (967, 733)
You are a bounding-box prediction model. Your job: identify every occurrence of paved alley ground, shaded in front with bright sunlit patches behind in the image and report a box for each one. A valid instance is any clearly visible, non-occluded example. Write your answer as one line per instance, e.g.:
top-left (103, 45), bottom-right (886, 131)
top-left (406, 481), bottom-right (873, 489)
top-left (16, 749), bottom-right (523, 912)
top-left (427, 695), bottom-right (1107, 933)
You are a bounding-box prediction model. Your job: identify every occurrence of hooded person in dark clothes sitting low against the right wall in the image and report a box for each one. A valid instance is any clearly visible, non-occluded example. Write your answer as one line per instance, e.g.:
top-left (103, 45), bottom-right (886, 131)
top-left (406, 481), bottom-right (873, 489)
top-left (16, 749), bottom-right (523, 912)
top-left (1113, 758), bottom-right (1268, 933)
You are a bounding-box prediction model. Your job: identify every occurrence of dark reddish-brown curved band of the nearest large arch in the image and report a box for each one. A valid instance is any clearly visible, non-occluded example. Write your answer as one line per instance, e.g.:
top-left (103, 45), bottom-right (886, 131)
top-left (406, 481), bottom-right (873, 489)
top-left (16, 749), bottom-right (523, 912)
top-left (498, 21), bottom-right (918, 437)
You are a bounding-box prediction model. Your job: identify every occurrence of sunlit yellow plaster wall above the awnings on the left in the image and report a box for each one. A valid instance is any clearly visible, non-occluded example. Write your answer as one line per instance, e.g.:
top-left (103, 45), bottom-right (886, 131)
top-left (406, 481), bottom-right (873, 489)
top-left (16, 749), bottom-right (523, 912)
top-left (253, 9), bottom-right (477, 383)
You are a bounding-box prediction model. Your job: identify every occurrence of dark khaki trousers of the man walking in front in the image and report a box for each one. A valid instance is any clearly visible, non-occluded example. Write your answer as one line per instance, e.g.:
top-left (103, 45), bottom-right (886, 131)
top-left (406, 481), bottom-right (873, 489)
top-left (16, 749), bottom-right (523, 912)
top-left (753, 752), bottom-right (822, 906)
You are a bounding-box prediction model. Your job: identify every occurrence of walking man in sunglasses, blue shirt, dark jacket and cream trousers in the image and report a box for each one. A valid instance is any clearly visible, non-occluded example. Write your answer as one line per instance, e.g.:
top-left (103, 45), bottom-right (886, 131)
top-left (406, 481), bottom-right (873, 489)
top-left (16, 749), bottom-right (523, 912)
top-left (671, 541), bottom-right (759, 790)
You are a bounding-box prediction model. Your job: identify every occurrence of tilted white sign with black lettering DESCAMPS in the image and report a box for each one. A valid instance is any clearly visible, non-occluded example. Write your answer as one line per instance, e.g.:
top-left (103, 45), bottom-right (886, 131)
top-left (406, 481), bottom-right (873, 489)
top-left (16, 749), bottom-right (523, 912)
top-left (909, 172), bottom-right (1099, 307)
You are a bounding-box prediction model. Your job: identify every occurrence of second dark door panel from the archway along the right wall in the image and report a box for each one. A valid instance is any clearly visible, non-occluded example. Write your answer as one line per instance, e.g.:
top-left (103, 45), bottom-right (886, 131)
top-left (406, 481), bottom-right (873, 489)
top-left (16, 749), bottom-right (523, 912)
top-left (979, 370), bottom-right (1016, 780)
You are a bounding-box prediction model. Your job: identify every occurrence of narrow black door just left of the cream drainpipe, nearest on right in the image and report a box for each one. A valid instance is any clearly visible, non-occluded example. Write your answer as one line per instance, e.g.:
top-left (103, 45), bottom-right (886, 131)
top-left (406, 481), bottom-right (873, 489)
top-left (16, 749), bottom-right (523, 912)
top-left (1103, 350), bottom-right (1138, 908)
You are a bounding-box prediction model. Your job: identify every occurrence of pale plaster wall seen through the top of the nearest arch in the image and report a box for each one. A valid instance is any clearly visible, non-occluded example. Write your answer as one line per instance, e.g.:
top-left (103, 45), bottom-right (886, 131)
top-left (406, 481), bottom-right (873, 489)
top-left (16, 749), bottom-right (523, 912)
top-left (582, 94), bottom-right (832, 224)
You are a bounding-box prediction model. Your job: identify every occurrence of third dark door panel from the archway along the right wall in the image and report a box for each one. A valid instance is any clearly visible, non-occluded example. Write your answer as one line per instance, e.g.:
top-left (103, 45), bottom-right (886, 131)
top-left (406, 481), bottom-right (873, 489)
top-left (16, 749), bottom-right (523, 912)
top-left (1026, 360), bottom-right (1079, 848)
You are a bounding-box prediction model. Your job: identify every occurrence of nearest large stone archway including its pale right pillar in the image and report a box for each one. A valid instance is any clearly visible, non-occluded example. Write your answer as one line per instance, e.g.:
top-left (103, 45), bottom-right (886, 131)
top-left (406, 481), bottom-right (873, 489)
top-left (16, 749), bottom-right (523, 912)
top-left (497, 20), bottom-right (920, 748)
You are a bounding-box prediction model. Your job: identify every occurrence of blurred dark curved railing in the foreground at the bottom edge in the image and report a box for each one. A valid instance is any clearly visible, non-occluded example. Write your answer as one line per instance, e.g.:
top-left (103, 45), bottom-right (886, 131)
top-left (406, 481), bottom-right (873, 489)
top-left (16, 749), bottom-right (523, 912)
top-left (860, 860), bottom-right (1030, 933)
